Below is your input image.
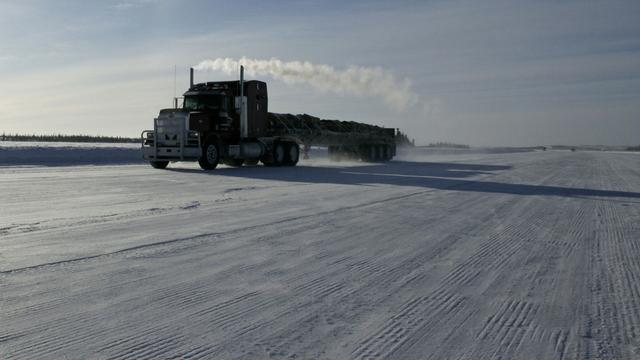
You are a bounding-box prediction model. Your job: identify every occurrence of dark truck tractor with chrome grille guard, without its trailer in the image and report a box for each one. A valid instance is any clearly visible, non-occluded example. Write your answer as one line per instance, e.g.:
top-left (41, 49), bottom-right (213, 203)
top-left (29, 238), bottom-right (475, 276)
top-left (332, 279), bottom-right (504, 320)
top-left (142, 71), bottom-right (300, 170)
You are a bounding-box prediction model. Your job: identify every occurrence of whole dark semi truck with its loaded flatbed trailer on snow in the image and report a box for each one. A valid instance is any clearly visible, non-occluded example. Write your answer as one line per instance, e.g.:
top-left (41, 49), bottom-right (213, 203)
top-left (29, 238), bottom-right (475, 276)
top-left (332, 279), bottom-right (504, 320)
top-left (142, 67), bottom-right (396, 170)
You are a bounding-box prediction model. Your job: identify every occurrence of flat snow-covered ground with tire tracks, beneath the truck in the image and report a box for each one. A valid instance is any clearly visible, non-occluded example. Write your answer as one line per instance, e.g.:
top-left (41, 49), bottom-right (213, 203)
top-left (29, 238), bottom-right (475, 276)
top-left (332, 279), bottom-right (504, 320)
top-left (0, 151), bottom-right (640, 359)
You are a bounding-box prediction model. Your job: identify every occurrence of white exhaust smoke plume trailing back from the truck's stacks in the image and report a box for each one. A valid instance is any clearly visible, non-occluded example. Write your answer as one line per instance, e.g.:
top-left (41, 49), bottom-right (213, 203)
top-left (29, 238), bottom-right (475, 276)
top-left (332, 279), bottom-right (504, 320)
top-left (194, 57), bottom-right (418, 110)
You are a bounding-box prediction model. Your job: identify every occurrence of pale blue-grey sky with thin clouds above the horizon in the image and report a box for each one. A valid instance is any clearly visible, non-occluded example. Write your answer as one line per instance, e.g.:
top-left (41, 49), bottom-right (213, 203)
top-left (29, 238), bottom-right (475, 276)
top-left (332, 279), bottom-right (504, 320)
top-left (0, 0), bottom-right (640, 146)
